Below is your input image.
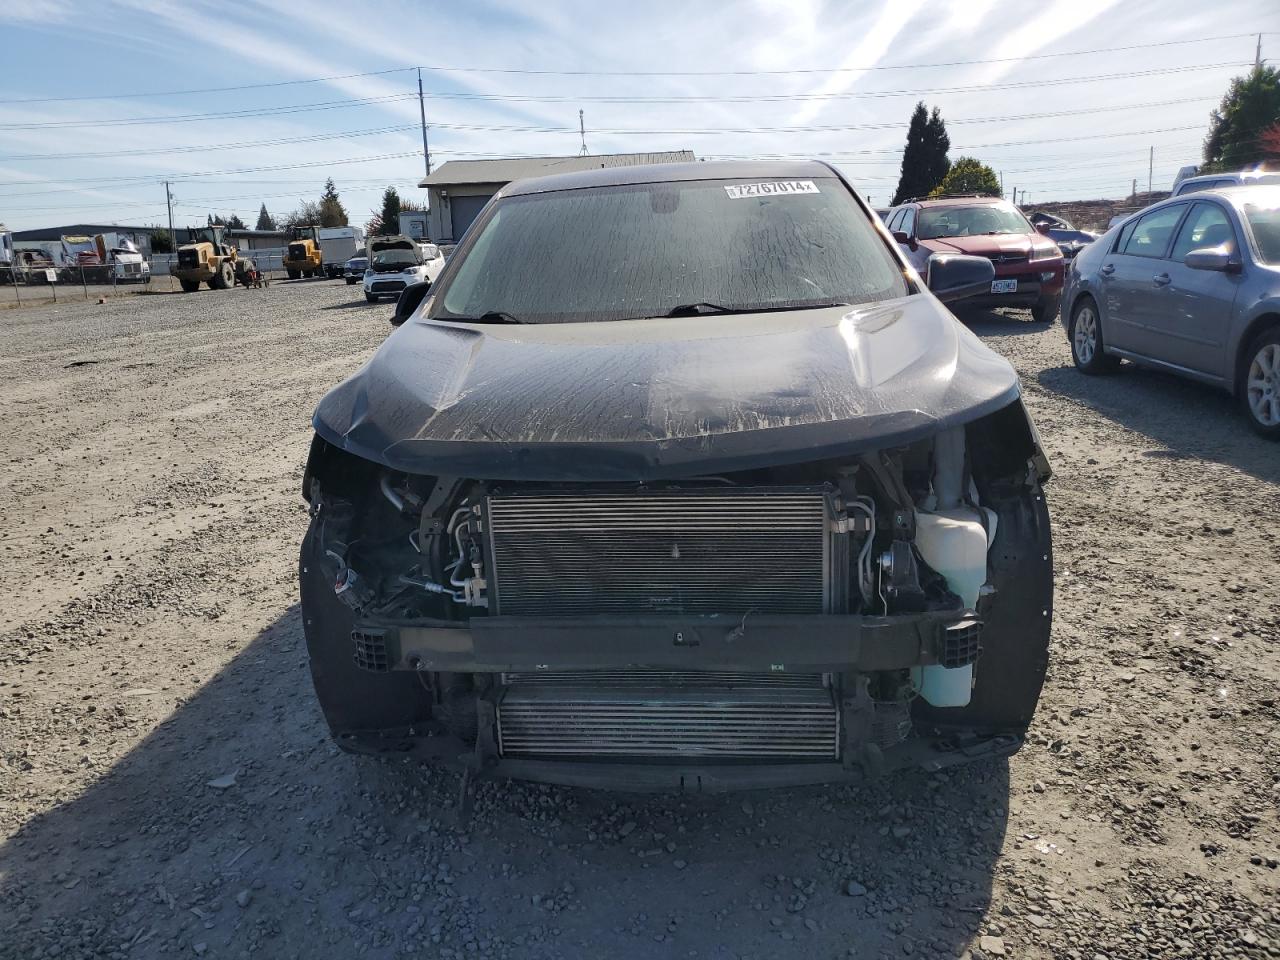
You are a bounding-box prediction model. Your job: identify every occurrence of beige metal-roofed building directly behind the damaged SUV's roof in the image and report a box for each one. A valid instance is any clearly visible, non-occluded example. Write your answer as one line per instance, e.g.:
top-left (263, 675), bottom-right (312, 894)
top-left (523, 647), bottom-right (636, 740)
top-left (417, 150), bottom-right (695, 243)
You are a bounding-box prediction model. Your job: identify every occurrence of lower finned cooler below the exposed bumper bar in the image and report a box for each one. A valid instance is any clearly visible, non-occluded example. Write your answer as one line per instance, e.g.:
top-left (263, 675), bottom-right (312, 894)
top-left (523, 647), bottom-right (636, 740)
top-left (498, 671), bottom-right (840, 762)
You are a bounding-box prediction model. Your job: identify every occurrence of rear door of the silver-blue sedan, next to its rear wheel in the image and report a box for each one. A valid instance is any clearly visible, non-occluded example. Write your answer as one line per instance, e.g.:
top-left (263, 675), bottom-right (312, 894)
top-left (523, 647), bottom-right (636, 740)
top-left (1098, 204), bottom-right (1190, 353)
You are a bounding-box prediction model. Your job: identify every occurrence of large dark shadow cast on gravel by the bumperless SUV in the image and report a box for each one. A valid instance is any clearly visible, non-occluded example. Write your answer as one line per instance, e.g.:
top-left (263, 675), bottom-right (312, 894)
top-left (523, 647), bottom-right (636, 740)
top-left (0, 607), bottom-right (1009, 960)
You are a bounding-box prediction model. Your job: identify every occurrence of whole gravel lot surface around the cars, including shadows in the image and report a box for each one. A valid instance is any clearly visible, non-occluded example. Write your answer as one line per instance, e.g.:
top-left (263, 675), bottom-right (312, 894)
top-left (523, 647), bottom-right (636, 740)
top-left (0, 283), bottom-right (1280, 960)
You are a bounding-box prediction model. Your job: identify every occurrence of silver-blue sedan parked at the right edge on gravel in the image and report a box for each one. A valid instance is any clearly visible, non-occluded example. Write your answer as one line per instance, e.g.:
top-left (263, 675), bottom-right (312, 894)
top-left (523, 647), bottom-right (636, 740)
top-left (1061, 186), bottom-right (1280, 440)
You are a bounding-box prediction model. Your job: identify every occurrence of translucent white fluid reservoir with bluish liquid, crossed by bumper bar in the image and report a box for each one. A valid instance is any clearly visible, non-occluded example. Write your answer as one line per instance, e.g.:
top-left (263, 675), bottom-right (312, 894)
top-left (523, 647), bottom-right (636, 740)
top-left (913, 507), bottom-right (987, 707)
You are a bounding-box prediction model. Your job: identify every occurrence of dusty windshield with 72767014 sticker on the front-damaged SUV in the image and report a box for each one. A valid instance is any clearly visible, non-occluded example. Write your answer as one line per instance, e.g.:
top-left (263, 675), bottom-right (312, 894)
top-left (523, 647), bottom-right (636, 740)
top-left (429, 178), bottom-right (909, 324)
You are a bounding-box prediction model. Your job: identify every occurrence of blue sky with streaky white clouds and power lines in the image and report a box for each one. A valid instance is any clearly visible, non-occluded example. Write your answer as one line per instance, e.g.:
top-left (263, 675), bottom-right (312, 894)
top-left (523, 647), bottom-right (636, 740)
top-left (0, 0), bottom-right (1280, 230)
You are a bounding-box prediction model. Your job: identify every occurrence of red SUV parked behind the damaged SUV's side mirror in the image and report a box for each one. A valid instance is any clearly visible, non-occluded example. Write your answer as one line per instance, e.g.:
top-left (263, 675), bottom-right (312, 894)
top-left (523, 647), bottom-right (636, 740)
top-left (886, 197), bottom-right (1064, 323)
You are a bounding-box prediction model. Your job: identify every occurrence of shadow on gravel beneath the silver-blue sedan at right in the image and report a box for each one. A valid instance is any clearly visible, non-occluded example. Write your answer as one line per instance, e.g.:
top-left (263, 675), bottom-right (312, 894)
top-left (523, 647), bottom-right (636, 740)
top-left (1037, 364), bottom-right (1280, 484)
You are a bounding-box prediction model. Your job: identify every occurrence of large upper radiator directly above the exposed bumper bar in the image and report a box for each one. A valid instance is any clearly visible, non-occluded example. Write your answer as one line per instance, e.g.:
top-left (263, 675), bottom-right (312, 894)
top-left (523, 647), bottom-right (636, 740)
top-left (485, 486), bottom-right (847, 617)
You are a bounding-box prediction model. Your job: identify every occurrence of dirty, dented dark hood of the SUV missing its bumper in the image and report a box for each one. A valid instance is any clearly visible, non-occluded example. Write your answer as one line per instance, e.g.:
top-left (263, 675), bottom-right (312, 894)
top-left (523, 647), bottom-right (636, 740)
top-left (314, 294), bottom-right (1019, 481)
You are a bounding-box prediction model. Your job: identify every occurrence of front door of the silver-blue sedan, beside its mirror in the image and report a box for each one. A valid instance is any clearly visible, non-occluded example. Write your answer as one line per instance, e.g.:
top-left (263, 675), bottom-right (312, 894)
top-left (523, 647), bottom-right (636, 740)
top-left (1143, 200), bottom-right (1240, 378)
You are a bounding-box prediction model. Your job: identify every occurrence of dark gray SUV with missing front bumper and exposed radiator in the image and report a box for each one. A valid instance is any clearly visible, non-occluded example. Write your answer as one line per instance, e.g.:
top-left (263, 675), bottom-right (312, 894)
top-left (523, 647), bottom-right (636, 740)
top-left (301, 163), bottom-right (1052, 791)
